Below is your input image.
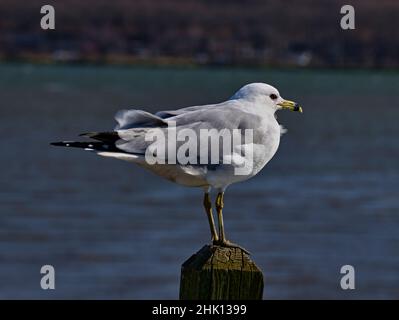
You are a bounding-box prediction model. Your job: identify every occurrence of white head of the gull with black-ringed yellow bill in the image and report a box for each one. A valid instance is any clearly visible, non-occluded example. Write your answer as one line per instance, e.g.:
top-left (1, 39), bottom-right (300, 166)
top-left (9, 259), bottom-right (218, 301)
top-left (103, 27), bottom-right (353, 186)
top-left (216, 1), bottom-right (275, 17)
top-left (231, 83), bottom-right (303, 113)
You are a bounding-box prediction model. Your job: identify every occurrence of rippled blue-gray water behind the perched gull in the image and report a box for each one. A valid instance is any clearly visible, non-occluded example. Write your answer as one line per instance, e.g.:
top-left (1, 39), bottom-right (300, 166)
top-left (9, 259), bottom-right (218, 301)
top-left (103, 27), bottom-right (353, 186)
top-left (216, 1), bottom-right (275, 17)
top-left (0, 65), bottom-right (399, 299)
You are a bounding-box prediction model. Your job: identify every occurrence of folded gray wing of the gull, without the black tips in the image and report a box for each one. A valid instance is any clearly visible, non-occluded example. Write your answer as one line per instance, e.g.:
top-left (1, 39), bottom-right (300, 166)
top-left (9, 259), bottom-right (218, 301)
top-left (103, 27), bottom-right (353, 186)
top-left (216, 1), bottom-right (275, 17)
top-left (116, 101), bottom-right (261, 163)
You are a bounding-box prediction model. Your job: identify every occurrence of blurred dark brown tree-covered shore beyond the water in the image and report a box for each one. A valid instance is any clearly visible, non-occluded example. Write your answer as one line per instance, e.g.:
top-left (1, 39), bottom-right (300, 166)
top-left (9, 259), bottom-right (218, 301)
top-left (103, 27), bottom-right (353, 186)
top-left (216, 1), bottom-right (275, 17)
top-left (0, 0), bottom-right (399, 67)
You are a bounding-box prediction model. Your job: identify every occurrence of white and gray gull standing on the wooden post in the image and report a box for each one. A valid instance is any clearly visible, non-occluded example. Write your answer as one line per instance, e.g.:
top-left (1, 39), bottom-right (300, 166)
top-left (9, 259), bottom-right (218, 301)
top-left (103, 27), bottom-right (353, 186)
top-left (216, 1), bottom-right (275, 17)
top-left (51, 83), bottom-right (303, 253)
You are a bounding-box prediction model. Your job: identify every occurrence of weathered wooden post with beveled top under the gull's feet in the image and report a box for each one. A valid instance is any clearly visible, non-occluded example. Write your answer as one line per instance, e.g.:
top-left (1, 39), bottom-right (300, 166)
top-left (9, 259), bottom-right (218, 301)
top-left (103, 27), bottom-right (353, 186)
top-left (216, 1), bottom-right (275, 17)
top-left (180, 245), bottom-right (263, 300)
